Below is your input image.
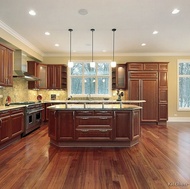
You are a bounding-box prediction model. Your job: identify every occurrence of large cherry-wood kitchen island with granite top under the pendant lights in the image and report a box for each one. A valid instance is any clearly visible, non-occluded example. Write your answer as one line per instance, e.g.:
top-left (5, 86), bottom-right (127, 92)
top-left (48, 101), bottom-right (144, 147)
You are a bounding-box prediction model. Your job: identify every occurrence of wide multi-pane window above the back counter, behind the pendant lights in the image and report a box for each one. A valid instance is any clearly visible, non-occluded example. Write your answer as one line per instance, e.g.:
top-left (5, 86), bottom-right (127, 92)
top-left (68, 62), bottom-right (112, 97)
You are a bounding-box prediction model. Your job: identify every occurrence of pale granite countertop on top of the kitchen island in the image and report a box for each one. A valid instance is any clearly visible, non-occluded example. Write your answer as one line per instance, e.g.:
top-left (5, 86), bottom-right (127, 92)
top-left (48, 104), bottom-right (142, 110)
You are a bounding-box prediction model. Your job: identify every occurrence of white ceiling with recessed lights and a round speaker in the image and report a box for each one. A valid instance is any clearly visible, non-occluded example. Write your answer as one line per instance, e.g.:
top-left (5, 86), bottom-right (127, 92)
top-left (0, 0), bottom-right (190, 56)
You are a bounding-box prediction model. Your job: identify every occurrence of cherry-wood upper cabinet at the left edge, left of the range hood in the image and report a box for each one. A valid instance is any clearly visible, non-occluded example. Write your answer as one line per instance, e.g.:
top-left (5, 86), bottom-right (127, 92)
top-left (0, 45), bottom-right (13, 87)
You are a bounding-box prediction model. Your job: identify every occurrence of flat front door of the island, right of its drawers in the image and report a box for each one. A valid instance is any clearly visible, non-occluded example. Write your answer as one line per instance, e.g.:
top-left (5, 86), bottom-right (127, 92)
top-left (115, 111), bottom-right (132, 141)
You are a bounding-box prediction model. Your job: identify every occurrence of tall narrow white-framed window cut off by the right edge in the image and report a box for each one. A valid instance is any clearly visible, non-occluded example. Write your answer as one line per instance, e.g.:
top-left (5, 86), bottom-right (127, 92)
top-left (177, 60), bottom-right (190, 111)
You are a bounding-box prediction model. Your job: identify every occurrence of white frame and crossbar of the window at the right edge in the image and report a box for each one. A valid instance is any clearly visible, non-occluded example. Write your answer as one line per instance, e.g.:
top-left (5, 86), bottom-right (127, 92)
top-left (177, 59), bottom-right (190, 112)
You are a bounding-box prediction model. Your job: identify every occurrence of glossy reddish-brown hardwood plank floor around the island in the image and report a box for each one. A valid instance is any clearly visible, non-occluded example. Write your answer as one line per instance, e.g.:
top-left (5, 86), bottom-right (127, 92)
top-left (0, 123), bottom-right (190, 189)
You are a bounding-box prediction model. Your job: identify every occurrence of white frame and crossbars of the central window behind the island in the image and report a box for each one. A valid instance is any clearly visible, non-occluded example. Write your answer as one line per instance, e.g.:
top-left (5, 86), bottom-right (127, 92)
top-left (67, 60), bottom-right (112, 98)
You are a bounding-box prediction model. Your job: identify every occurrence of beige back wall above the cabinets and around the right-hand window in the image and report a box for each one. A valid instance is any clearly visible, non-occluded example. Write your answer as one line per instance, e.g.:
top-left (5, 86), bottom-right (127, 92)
top-left (44, 56), bottom-right (190, 118)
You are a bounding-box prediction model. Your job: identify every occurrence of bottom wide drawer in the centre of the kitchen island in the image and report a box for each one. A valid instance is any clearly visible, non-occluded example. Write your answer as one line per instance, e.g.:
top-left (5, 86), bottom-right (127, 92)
top-left (76, 128), bottom-right (112, 141)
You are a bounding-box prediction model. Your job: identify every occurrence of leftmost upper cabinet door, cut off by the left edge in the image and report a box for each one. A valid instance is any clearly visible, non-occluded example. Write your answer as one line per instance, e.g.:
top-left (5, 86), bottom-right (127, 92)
top-left (0, 45), bottom-right (6, 86)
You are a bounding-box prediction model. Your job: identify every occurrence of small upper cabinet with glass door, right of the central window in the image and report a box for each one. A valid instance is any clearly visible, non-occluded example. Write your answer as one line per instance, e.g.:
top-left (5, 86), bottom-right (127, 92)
top-left (112, 64), bottom-right (127, 89)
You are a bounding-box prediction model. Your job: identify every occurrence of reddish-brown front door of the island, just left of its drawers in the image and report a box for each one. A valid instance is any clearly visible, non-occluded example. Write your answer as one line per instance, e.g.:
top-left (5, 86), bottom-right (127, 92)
top-left (57, 111), bottom-right (74, 141)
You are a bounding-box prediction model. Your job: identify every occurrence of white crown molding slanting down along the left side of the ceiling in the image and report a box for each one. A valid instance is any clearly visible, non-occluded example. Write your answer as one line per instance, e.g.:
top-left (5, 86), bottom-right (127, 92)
top-left (0, 20), bottom-right (44, 56)
